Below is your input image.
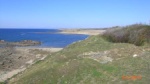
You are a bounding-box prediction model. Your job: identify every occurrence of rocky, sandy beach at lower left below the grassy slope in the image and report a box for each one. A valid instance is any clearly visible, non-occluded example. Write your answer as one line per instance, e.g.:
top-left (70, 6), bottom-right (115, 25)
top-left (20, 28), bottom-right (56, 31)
top-left (0, 47), bottom-right (62, 82)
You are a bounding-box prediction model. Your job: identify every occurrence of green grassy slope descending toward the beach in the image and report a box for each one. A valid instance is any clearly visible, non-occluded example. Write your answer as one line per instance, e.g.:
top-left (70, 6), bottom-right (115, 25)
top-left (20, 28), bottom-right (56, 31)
top-left (9, 36), bottom-right (150, 84)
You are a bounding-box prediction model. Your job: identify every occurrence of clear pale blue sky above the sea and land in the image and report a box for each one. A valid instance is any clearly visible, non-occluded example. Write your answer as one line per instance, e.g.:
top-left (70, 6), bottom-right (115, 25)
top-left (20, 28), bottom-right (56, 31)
top-left (0, 0), bottom-right (150, 28)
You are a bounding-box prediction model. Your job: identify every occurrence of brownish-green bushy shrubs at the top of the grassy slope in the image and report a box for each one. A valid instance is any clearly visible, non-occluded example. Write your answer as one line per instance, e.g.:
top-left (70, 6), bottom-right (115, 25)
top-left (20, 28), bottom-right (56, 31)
top-left (103, 24), bottom-right (150, 46)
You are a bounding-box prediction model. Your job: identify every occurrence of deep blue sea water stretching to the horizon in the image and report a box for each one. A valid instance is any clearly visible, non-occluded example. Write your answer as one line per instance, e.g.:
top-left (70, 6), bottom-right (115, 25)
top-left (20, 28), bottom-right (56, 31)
top-left (0, 29), bottom-right (88, 48)
